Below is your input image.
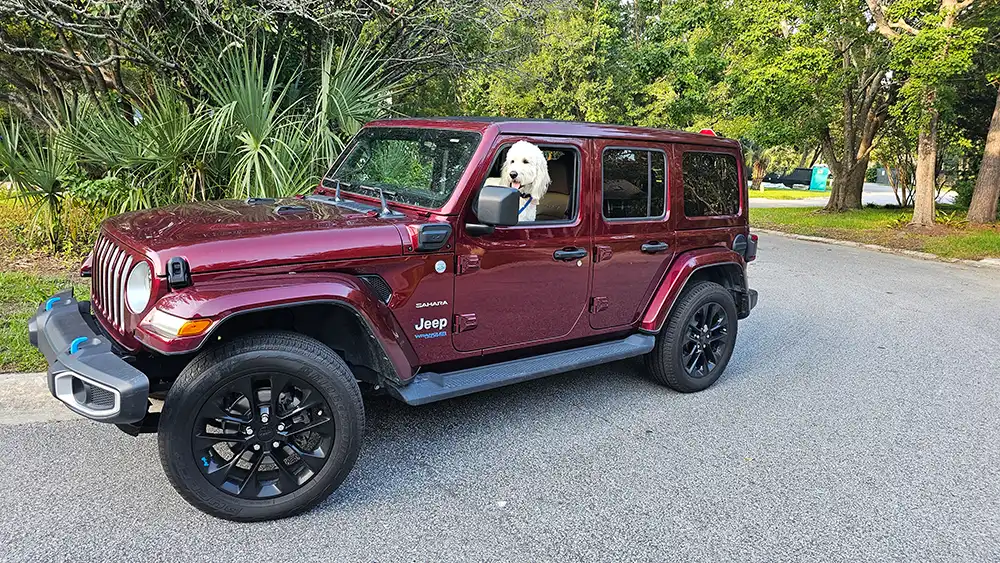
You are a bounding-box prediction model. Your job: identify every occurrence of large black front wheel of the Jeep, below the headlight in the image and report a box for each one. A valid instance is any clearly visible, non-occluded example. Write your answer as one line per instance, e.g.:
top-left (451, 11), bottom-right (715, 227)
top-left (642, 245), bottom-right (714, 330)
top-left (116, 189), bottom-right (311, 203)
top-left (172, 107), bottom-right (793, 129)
top-left (158, 331), bottom-right (365, 522)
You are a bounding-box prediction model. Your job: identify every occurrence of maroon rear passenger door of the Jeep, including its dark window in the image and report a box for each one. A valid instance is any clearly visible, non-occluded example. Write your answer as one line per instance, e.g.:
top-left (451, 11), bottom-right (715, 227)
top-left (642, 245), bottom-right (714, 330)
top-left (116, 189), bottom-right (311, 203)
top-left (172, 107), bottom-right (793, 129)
top-left (590, 140), bottom-right (674, 329)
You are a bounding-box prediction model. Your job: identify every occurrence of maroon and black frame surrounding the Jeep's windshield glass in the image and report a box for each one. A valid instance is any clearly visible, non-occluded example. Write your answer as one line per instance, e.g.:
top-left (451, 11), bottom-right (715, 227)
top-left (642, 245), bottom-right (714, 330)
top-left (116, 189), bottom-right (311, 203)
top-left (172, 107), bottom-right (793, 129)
top-left (317, 123), bottom-right (488, 213)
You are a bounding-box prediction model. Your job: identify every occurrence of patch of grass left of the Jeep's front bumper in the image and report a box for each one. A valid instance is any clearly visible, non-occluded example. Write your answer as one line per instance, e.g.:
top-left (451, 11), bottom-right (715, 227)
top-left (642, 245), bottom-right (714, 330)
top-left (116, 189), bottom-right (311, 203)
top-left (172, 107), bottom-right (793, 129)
top-left (0, 272), bottom-right (90, 373)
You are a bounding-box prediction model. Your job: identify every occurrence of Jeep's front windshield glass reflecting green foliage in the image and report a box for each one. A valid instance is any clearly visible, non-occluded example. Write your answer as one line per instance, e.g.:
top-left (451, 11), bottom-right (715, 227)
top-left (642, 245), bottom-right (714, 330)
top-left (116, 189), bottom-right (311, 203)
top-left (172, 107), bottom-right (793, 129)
top-left (327, 127), bottom-right (480, 209)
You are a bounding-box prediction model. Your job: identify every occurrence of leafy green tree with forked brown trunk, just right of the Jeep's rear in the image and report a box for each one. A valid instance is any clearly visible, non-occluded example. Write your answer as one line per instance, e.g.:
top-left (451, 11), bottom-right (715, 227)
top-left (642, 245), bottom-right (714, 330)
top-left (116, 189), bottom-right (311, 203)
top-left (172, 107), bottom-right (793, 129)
top-left (729, 0), bottom-right (896, 211)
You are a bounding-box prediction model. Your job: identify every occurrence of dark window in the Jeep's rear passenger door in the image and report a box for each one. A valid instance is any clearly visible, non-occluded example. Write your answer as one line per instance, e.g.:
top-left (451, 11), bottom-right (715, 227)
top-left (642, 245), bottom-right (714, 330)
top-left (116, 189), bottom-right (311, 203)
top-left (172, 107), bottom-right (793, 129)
top-left (601, 149), bottom-right (667, 219)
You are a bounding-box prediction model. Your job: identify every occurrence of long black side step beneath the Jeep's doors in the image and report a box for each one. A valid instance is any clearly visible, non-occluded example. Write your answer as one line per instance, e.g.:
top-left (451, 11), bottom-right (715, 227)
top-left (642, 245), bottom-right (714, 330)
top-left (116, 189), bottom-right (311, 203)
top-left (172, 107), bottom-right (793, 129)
top-left (389, 334), bottom-right (656, 405)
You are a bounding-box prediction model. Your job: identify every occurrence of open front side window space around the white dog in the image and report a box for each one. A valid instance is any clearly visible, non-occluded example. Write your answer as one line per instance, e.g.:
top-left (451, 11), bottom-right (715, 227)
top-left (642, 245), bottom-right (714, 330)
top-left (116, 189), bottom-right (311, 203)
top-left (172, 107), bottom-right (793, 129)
top-left (485, 144), bottom-right (580, 225)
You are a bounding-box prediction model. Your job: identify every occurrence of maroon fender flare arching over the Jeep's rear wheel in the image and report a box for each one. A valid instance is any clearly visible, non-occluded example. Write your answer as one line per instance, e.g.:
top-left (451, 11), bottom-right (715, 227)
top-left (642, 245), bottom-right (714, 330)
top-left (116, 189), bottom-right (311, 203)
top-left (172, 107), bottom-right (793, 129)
top-left (639, 247), bottom-right (747, 334)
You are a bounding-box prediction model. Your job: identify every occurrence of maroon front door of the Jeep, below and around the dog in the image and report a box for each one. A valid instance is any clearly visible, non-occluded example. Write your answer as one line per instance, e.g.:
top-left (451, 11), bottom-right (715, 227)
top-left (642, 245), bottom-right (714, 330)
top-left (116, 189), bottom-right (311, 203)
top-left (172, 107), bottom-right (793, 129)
top-left (452, 136), bottom-right (592, 351)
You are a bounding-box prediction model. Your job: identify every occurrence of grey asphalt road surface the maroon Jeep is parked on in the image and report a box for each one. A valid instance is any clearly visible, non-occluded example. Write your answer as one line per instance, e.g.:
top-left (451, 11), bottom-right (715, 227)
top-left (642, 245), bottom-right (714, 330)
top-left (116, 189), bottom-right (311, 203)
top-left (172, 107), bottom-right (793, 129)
top-left (0, 236), bottom-right (1000, 562)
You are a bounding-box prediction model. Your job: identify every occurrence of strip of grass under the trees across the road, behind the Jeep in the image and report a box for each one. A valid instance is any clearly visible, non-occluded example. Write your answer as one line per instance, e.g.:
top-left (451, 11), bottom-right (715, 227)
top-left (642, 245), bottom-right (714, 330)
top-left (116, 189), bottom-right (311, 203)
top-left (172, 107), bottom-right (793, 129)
top-left (750, 206), bottom-right (1000, 260)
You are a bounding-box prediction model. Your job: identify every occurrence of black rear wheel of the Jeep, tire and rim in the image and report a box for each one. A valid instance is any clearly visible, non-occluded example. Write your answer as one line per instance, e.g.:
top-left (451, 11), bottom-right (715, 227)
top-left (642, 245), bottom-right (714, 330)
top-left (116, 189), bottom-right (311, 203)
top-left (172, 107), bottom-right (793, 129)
top-left (646, 281), bottom-right (737, 393)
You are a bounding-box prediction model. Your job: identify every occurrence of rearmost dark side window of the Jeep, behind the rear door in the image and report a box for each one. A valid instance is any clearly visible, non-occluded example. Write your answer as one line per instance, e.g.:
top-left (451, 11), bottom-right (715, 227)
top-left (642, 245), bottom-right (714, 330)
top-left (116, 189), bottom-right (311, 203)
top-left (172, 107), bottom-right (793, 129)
top-left (682, 152), bottom-right (740, 217)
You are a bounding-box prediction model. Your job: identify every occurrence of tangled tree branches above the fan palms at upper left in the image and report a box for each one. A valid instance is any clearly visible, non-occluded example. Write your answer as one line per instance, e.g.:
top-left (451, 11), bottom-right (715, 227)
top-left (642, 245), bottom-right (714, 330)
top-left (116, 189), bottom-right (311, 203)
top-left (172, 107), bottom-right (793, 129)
top-left (0, 0), bottom-right (512, 125)
